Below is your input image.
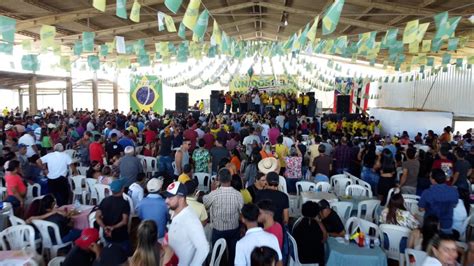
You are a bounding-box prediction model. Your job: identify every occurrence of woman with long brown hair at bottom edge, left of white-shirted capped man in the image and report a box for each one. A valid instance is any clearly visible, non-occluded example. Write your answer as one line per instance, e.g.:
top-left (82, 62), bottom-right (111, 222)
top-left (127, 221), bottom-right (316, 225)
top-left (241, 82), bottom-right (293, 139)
top-left (130, 220), bottom-right (160, 266)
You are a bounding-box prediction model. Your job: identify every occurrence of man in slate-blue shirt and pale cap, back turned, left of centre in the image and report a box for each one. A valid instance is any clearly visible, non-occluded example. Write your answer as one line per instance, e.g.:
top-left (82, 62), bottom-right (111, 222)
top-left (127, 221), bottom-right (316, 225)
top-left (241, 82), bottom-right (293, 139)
top-left (118, 146), bottom-right (143, 187)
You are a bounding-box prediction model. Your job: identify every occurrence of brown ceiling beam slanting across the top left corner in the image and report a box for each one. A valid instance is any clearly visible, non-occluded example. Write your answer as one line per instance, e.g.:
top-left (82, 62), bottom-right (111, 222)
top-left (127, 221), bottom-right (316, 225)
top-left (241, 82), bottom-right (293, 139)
top-left (16, 0), bottom-right (164, 31)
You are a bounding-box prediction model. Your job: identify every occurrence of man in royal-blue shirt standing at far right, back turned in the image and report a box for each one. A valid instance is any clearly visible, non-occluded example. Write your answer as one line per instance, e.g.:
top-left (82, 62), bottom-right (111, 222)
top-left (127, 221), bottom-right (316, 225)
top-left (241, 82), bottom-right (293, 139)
top-left (418, 169), bottom-right (459, 234)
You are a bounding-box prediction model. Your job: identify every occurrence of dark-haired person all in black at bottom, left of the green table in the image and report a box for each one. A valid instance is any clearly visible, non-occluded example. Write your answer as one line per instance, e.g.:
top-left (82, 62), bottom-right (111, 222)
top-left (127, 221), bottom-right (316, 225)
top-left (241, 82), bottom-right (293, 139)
top-left (292, 201), bottom-right (327, 266)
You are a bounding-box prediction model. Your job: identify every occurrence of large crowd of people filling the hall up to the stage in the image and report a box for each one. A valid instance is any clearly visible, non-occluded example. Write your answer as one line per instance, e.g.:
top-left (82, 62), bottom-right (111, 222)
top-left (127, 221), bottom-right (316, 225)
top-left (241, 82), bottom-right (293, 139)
top-left (0, 100), bottom-right (474, 265)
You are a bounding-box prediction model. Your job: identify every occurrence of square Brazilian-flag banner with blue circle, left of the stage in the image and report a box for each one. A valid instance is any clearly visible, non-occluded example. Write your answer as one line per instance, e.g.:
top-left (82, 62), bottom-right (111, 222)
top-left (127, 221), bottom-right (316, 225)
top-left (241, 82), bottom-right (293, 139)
top-left (130, 75), bottom-right (163, 114)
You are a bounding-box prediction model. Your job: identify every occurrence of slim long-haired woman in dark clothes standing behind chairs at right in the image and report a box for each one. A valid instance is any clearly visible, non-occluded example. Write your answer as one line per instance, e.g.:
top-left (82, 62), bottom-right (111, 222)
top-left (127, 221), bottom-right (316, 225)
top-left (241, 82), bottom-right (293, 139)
top-left (377, 149), bottom-right (396, 205)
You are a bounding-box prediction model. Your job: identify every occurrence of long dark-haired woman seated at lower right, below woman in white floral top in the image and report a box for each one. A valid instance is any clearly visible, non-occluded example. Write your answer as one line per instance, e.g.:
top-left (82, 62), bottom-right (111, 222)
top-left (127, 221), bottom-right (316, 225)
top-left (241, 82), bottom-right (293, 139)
top-left (408, 215), bottom-right (439, 251)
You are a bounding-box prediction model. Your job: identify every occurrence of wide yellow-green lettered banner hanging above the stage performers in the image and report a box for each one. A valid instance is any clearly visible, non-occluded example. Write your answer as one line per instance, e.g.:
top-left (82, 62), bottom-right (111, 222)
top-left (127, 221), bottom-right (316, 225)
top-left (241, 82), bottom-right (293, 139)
top-left (229, 75), bottom-right (298, 92)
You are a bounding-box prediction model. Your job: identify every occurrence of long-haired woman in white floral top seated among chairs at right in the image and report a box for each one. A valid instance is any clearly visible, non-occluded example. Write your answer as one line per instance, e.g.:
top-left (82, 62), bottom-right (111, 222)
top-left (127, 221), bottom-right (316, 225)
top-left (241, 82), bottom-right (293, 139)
top-left (380, 193), bottom-right (420, 230)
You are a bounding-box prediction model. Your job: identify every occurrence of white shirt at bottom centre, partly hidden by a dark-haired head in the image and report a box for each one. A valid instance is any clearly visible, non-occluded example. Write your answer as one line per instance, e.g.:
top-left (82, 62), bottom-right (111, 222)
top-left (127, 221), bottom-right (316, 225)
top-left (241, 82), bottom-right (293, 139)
top-left (234, 227), bottom-right (282, 266)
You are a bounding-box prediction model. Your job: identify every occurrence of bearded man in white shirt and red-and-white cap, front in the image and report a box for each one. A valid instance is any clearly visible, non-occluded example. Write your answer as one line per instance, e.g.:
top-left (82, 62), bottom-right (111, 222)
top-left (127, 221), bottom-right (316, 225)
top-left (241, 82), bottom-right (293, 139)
top-left (165, 181), bottom-right (209, 266)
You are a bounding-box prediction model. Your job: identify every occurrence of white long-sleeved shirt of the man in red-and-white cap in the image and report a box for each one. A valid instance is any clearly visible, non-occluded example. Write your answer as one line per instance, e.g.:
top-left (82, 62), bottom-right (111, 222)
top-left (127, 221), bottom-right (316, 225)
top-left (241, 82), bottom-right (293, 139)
top-left (168, 206), bottom-right (209, 266)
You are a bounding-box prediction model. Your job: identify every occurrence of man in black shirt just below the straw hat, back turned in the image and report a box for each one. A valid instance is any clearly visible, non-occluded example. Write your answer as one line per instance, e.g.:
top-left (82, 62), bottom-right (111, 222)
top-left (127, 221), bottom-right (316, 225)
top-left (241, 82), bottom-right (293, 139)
top-left (254, 172), bottom-right (290, 226)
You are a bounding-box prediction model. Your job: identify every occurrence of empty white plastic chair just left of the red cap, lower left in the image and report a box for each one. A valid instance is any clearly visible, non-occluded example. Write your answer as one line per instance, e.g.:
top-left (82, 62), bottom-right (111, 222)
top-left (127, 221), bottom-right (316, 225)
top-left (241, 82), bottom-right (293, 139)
top-left (31, 220), bottom-right (72, 258)
